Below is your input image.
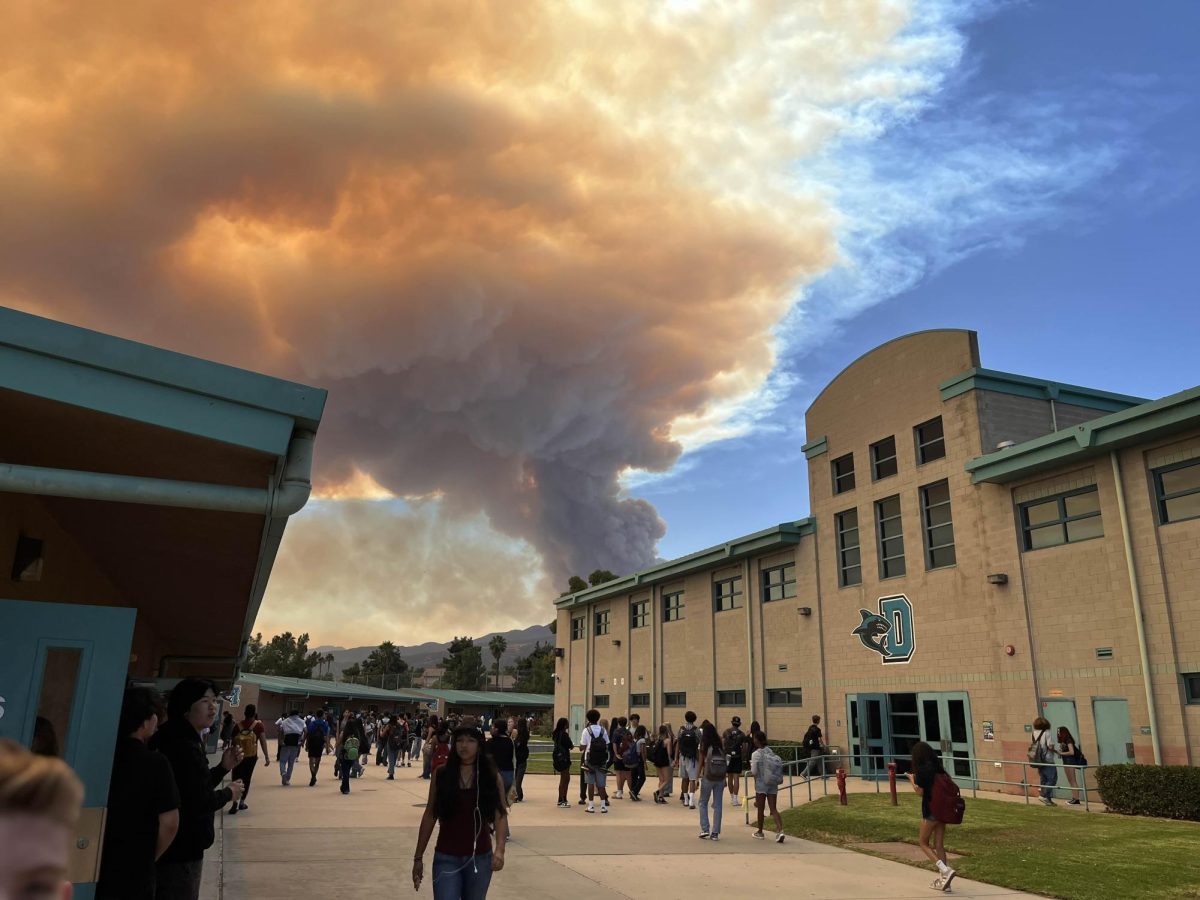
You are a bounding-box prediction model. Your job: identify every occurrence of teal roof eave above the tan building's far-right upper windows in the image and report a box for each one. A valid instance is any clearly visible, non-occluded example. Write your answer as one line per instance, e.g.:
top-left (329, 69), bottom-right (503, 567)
top-left (966, 386), bottom-right (1200, 484)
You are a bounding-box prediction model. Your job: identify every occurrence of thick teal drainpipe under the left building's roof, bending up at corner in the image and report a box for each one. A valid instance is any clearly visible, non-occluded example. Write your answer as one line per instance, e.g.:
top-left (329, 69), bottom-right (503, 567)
top-left (0, 431), bottom-right (314, 518)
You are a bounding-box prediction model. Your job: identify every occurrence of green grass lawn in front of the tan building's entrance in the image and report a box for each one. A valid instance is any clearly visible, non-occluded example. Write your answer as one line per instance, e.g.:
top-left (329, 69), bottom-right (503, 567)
top-left (784, 793), bottom-right (1200, 900)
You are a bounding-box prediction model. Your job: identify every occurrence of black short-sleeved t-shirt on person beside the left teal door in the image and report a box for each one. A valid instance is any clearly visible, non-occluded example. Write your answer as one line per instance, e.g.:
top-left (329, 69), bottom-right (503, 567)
top-left (97, 738), bottom-right (179, 900)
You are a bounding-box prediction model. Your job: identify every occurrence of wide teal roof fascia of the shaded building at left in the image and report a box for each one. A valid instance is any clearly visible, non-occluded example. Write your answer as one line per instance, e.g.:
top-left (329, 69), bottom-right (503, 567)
top-left (0, 307), bottom-right (326, 455)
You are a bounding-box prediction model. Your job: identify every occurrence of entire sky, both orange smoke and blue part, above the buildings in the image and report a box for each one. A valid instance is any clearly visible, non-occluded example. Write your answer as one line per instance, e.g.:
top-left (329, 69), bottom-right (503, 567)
top-left (0, 0), bottom-right (1200, 646)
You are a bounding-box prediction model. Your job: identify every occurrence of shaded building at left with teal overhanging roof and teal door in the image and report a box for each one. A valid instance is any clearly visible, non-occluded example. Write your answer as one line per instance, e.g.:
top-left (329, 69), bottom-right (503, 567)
top-left (0, 307), bottom-right (325, 900)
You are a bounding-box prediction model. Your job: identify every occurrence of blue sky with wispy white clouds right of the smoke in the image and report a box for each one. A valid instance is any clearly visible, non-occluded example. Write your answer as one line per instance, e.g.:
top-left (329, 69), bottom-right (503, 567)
top-left (631, 0), bottom-right (1200, 558)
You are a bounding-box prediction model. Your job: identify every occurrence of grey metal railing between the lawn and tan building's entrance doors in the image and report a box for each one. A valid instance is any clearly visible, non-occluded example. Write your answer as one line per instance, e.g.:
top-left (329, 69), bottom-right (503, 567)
top-left (742, 754), bottom-right (1104, 823)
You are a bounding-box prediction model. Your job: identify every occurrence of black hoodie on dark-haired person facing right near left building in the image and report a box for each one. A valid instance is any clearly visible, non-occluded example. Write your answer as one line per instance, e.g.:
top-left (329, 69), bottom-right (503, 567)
top-left (150, 718), bottom-right (233, 863)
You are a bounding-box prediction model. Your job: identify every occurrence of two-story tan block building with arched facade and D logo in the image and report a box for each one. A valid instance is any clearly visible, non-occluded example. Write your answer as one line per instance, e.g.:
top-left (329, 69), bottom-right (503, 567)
top-left (554, 330), bottom-right (1200, 780)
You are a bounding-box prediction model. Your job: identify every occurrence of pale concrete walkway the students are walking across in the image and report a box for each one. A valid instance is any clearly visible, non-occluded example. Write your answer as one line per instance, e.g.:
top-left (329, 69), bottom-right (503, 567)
top-left (202, 760), bottom-right (1032, 900)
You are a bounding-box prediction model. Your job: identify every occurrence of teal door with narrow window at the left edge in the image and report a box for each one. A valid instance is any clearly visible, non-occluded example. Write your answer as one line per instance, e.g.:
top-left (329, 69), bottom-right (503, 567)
top-left (0, 600), bottom-right (136, 900)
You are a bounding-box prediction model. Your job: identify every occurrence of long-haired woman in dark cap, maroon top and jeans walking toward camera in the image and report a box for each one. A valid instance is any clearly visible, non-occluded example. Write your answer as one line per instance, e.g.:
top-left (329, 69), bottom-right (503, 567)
top-left (413, 726), bottom-right (508, 900)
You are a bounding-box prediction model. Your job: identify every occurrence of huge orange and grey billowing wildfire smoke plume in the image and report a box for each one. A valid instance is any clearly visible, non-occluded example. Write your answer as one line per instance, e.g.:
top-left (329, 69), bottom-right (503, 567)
top-left (0, 0), bottom-right (974, 643)
